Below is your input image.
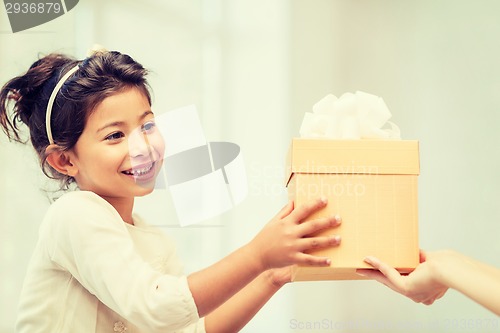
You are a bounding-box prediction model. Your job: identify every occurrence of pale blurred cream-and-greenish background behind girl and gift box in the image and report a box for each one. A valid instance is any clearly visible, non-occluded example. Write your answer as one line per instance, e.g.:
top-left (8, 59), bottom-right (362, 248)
top-left (0, 0), bottom-right (500, 333)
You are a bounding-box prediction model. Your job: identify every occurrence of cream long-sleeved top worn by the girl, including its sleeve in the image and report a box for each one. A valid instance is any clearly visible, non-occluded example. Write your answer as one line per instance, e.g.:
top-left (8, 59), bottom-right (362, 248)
top-left (16, 191), bottom-right (205, 333)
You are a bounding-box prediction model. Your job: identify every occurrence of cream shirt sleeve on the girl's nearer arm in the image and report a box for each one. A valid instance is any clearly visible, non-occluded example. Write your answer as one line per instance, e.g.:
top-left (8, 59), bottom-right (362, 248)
top-left (41, 191), bottom-right (203, 332)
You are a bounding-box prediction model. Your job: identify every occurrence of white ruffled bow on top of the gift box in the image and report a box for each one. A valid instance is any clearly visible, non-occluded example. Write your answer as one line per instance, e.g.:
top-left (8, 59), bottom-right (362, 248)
top-left (300, 91), bottom-right (401, 140)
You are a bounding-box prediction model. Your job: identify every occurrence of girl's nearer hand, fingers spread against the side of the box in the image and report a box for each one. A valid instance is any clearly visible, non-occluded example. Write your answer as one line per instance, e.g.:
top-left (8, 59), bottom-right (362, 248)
top-left (248, 199), bottom-right (341, 270)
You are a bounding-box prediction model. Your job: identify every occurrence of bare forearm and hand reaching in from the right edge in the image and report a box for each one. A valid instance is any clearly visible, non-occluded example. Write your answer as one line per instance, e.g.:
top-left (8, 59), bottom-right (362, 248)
top-left (358, 250), bottom-right (500, 315)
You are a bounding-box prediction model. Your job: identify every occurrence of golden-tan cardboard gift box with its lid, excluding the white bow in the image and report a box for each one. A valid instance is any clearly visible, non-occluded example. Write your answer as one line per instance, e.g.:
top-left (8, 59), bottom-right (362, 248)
top-left (286, 138), bottom-right (420, 281)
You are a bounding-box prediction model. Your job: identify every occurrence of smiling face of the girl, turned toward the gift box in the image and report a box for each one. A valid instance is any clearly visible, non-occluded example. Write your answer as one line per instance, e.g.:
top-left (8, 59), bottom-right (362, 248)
top-left (71, 88), bottom-right (164, 201)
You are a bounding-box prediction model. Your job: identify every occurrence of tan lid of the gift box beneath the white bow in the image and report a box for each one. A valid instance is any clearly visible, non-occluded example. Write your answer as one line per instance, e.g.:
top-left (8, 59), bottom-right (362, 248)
top-left (285, 138), bottom-right (420, 186)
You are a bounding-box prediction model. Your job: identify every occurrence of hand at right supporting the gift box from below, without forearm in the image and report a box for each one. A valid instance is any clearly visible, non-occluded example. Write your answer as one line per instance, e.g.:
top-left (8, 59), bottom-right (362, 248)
top-left (357, 251), bottom-right (448, 305)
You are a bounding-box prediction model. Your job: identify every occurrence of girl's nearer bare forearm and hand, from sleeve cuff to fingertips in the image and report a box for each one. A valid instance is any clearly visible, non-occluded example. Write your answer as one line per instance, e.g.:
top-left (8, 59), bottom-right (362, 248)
top-left (188, 200), bottom-right (340, 317)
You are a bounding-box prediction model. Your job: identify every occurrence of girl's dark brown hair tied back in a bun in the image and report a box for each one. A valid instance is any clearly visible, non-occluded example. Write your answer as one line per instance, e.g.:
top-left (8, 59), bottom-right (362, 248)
top-left (0, 51), bottom-right (151, 188)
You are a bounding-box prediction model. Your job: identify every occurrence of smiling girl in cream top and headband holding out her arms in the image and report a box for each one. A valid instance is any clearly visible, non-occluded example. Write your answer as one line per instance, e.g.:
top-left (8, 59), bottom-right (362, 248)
top-left (0, 52), bottom-right (340, 333)
